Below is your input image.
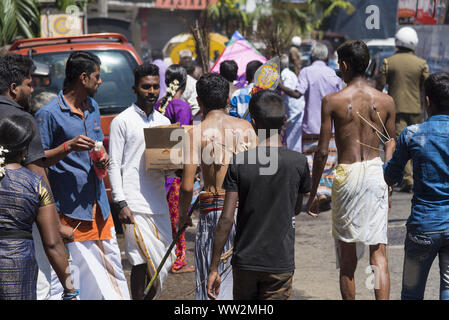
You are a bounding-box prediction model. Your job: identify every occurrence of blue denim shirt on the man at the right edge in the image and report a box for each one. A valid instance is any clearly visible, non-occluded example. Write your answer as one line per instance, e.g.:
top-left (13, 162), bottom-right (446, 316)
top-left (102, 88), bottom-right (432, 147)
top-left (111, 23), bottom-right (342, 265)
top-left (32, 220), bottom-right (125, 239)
top-left (384, 114), bottom-right (449, 232)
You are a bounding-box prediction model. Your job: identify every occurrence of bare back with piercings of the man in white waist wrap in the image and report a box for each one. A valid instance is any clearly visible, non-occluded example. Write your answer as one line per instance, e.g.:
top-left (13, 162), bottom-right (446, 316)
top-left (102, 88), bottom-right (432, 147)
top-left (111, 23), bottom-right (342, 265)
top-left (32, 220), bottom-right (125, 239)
top-left (323, 81), bottom-right (395, 164)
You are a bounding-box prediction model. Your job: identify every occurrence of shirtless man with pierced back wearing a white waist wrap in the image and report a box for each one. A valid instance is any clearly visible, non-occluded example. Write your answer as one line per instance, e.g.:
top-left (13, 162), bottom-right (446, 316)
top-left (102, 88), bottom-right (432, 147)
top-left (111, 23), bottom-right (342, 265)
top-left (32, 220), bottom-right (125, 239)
top-left (307, 41), bottom-right (395, 300)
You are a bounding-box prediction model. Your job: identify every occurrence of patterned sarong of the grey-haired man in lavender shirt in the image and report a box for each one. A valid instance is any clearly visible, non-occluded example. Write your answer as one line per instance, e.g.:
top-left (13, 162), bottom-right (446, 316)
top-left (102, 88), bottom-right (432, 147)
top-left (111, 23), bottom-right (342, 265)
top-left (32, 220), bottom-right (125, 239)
top-left (302, 134), bottom-right (338, 198)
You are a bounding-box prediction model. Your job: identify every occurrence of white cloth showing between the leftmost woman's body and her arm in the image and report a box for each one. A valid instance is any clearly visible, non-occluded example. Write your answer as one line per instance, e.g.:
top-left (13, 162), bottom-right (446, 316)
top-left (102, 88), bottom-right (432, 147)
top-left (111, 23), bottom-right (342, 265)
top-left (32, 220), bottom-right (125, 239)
top-left (33, 223), bottom-right (51, 300)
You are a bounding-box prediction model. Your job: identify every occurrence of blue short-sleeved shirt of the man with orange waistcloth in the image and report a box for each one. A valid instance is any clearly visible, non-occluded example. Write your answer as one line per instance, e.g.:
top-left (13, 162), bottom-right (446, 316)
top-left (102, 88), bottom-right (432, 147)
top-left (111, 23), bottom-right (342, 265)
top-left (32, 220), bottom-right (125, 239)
top-left (36, 91), bottom-right (110, 221)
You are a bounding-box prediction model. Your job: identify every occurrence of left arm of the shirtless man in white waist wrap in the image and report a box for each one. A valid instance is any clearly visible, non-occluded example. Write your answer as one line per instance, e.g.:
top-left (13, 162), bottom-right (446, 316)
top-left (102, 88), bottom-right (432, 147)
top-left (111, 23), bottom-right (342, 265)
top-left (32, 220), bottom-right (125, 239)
top-left (306, 96), bottom-right (332, 217)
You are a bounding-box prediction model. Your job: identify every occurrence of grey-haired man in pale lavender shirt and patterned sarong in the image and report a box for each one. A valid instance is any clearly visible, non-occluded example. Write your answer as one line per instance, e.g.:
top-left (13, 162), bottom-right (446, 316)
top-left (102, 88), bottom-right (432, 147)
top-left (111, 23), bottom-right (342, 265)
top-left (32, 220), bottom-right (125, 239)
top-left (297, 42), bottom-right (342, 210)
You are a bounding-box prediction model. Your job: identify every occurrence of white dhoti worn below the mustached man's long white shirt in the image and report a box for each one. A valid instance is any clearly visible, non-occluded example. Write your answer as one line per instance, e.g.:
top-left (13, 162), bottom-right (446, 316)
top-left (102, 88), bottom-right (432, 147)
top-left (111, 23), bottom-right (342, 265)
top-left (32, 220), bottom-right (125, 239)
top-left (123, 213), bottom-right (176, 299)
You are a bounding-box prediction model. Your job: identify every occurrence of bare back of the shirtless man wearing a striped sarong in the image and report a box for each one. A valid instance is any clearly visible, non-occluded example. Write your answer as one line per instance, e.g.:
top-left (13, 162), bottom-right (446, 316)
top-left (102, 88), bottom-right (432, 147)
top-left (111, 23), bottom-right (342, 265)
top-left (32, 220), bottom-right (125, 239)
top-left (194, 112), bottom-right (257, 193)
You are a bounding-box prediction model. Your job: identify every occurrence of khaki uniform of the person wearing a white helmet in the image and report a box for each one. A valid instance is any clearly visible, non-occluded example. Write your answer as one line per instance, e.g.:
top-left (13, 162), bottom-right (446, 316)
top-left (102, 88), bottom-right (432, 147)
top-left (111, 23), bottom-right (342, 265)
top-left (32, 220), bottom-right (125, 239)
top-left (377, 51), bottom-right (429, 186)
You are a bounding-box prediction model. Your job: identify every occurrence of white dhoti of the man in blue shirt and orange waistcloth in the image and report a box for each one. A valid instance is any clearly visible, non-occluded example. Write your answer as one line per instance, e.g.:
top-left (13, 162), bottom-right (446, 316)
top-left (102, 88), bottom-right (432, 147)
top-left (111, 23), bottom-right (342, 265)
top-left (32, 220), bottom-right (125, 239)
top-left (50, 232), bottom-right (130, 300)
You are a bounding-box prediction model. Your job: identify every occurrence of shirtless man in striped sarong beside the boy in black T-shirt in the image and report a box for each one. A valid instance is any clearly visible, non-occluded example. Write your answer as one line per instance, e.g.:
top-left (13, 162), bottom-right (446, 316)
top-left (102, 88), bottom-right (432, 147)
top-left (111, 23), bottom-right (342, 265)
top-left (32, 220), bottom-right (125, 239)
top-left (178, 73), bottom-right (257, 300)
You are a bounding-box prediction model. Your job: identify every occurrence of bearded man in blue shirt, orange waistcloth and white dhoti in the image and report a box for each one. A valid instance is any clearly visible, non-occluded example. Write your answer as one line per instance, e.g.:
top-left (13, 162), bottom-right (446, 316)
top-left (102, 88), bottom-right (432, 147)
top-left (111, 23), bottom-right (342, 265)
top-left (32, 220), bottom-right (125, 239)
top-left (36, 51), bottom-right (129, 300)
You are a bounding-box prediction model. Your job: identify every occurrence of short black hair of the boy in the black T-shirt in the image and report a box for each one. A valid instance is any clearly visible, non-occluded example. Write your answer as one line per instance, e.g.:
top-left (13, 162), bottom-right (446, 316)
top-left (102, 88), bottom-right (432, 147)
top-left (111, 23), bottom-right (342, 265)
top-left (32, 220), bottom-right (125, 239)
top-left (249, 90), bottom-right (285, 130)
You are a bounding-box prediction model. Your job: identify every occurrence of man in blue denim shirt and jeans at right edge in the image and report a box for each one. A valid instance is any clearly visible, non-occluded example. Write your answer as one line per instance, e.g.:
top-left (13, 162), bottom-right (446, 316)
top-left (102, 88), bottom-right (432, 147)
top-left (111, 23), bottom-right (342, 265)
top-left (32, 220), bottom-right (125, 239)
top-left (384, 72), bottom-right (449, 300)
